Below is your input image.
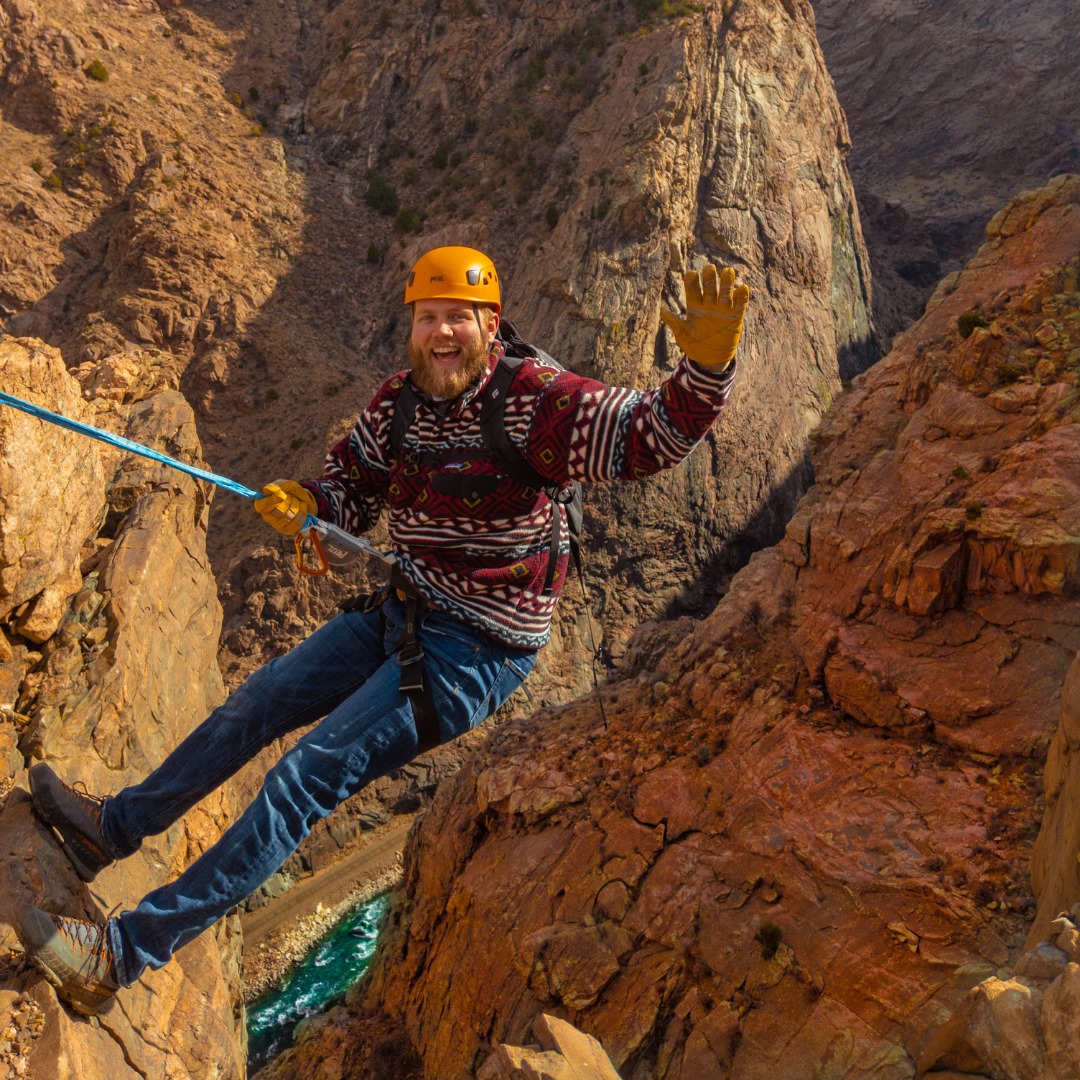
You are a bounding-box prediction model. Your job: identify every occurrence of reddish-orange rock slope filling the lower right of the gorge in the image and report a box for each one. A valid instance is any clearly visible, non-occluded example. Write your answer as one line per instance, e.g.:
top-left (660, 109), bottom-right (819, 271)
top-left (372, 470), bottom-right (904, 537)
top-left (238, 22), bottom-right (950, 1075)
top-left (261, 177), bottom-right (1080, 1080)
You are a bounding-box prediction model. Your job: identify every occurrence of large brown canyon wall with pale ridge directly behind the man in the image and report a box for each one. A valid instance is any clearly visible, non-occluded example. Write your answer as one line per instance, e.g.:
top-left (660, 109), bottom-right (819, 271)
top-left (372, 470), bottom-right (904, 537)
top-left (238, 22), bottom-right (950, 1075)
top-left (0, 0), bottom-right (870, 928)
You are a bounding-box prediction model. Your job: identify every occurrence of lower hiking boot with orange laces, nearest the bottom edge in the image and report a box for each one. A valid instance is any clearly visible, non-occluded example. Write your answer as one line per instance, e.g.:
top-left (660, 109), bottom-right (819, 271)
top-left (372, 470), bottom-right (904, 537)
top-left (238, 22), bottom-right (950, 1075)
top-left (15, 904), bottom-right (120, 1016)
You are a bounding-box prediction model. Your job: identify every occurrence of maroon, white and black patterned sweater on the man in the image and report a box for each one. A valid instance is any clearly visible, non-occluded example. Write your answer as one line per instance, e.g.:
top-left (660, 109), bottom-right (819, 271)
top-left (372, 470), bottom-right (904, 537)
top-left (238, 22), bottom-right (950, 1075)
top-left (305, 342), bottom-right (735, 649)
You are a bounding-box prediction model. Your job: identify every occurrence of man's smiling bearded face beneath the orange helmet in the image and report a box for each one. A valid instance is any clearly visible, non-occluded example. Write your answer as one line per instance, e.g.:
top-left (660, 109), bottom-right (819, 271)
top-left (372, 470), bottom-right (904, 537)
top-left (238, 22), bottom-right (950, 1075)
top-left (409, 300), bottom-right (499, 397)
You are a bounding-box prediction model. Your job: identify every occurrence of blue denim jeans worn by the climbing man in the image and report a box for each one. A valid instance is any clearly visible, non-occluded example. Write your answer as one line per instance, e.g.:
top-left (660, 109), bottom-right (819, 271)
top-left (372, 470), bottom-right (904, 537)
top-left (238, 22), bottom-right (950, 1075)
top-left (102, 596), bottom-right (536, 986)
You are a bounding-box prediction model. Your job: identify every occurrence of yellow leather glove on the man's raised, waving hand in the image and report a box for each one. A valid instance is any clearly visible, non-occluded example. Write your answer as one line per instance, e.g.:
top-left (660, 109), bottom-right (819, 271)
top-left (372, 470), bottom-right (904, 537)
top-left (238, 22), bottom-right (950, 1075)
top-left (660, 262), bottom-right (750, 372)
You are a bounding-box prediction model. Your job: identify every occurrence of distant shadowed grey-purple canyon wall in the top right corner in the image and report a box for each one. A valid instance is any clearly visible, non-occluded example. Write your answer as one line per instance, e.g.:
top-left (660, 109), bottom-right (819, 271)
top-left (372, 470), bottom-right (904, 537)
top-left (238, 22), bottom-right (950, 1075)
top-left (813, 0), bottom-right (1080, 348)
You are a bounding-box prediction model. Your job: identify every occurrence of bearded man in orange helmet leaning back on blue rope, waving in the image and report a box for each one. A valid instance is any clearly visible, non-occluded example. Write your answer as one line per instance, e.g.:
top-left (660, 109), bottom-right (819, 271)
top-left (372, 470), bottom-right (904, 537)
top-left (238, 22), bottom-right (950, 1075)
top-left (16, 247), bottom-right (750, 1014)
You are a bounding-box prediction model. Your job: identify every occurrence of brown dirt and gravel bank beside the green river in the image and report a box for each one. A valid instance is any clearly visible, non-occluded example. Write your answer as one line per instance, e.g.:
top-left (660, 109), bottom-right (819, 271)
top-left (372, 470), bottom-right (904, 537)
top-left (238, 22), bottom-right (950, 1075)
top-left (240, 816), bottom-right (414, 1003)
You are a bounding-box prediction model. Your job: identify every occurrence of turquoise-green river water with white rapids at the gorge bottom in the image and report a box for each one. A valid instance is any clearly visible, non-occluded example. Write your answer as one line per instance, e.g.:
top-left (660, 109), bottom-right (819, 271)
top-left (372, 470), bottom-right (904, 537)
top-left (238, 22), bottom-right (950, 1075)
top-left (247, 896), bottom-right (387, 1074)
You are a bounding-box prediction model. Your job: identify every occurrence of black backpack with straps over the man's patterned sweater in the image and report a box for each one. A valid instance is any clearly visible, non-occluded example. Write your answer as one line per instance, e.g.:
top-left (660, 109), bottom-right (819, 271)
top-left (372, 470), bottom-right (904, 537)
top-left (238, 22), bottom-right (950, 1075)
top-left (390, 320), bottom-right (582, 593)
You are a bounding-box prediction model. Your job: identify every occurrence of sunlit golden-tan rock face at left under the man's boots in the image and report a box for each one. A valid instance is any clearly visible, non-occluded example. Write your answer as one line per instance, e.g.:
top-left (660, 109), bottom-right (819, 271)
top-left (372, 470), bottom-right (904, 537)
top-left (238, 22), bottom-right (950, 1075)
top-left (0, 338), bottom-right (245, 1080)
